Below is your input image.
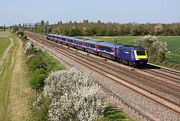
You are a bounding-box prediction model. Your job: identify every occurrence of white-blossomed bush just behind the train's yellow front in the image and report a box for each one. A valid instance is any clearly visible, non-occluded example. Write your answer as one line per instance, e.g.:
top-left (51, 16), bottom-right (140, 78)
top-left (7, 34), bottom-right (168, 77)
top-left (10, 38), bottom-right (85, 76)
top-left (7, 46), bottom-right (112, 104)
top-left (134, 35), bottom-right (170, 62)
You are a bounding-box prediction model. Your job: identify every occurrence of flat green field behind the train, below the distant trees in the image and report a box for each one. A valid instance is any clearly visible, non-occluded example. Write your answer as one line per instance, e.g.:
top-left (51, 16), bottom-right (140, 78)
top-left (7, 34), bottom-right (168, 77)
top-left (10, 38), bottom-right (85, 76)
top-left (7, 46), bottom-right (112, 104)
top-left (81, 36), bottom-right (180, 64)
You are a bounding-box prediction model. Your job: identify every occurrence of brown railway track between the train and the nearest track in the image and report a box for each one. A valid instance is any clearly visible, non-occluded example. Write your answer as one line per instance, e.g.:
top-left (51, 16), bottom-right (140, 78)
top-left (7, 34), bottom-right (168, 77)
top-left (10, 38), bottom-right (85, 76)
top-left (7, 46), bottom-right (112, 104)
top-left (26, 33), bottom-right (180, 101)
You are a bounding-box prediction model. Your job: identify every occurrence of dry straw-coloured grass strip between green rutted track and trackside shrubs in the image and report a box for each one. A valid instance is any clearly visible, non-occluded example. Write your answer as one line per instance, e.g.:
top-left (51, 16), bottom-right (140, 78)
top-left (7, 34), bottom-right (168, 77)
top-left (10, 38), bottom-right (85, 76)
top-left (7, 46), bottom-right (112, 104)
top-left (8, 38), bottom-right (32, 121)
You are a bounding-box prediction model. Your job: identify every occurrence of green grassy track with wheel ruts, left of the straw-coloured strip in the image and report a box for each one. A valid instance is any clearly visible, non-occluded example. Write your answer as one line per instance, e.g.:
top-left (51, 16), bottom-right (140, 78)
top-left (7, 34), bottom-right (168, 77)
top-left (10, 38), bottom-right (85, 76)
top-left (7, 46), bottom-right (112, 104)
top-left (0, 36), bottom-right (18, 121)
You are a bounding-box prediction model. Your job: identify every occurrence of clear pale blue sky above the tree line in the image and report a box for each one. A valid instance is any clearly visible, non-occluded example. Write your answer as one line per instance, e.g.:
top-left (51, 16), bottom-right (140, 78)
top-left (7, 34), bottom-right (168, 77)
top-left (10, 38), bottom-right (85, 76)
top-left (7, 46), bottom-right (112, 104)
top-left (0, 0), bottom-right (180, 25)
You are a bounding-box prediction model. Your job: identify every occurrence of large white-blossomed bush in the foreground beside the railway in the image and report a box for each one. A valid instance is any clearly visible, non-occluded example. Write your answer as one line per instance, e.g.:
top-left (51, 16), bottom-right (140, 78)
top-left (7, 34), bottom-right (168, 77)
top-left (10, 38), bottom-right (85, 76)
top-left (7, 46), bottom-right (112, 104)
top-left (43, 68), bottom-right (105, 121)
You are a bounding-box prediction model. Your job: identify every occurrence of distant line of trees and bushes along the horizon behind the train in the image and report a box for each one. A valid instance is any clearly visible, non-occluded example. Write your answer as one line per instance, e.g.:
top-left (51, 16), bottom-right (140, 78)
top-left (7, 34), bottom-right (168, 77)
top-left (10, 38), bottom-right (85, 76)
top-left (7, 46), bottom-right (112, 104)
top-left (29, 20), bottom-right (180, 36)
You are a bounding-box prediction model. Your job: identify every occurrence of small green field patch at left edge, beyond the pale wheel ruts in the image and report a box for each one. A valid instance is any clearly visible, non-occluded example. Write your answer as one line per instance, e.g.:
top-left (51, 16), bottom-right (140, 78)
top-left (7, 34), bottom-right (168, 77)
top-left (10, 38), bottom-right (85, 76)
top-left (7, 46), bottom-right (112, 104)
top-left (0, 37), bottom-right (10, 59)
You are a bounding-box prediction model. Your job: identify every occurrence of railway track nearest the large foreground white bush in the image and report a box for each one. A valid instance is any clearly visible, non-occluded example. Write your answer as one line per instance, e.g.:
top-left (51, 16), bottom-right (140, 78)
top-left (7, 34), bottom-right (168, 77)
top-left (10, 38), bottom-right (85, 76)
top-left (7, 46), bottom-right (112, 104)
top-left (26, 31), bottom-right (180, 113)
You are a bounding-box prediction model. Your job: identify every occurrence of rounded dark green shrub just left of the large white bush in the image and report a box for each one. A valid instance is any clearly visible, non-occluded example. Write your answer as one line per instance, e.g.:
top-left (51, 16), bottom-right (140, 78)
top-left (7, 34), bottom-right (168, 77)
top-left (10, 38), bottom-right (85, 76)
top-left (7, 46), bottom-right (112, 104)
top-left (30, 68), bottom-right (47, 91)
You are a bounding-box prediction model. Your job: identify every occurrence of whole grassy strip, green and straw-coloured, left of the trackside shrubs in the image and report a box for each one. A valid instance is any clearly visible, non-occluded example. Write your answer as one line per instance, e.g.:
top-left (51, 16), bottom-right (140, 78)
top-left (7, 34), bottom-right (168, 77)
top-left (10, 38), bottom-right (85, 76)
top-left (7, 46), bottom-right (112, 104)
top-left (0, 31), bottom-right (32, 121)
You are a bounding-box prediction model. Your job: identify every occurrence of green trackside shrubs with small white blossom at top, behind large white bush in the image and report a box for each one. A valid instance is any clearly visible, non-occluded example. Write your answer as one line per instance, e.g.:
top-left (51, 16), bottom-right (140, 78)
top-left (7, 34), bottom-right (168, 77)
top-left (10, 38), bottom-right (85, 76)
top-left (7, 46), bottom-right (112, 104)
top-left (24, 42), bottom-right (64, 91)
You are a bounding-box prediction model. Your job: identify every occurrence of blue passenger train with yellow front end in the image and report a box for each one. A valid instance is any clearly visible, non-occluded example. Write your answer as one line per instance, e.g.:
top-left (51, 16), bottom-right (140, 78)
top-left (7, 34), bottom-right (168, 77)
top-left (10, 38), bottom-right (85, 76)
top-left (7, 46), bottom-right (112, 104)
top-left (47, 34), bottom-right (148, 67)
